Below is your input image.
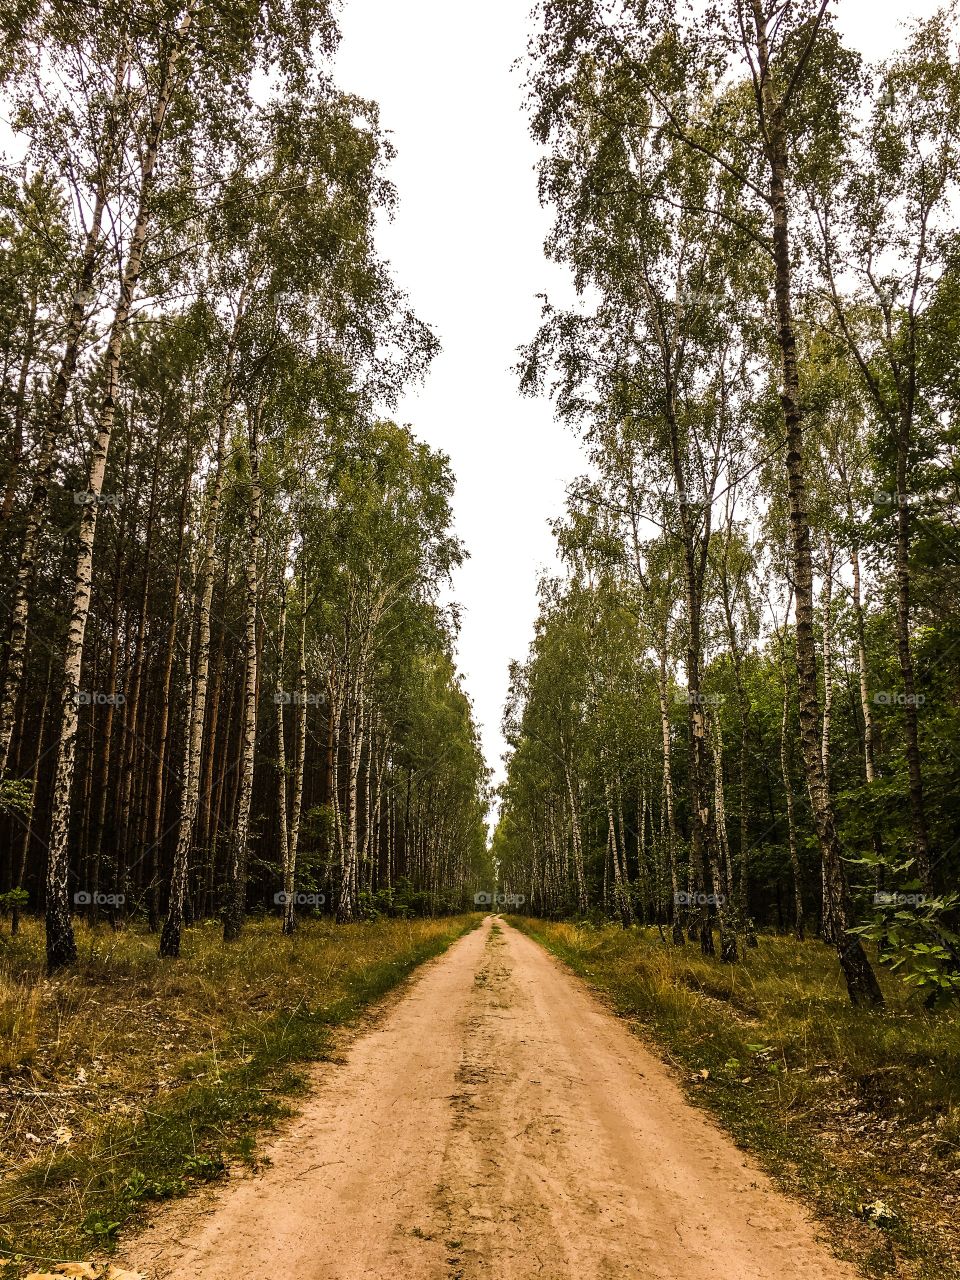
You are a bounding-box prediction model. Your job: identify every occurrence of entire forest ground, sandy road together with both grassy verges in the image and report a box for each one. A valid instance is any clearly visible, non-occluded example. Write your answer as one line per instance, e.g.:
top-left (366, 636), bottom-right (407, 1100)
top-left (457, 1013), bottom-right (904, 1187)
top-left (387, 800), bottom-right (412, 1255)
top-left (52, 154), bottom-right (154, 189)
top-left (0, 916), bottom-right (960, 1280)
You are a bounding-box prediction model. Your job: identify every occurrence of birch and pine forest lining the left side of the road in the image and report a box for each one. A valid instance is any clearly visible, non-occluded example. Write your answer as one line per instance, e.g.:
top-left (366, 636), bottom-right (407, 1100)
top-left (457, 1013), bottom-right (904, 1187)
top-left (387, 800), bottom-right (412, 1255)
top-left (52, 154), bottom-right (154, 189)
top-left (0, 0), bottom-right (486, 969)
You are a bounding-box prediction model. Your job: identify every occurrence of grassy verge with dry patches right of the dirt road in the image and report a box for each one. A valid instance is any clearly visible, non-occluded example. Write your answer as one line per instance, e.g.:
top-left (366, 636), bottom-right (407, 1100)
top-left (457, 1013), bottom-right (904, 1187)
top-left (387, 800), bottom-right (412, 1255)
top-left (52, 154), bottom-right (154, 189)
top-left (512, 919), bottom-right (960, 1280)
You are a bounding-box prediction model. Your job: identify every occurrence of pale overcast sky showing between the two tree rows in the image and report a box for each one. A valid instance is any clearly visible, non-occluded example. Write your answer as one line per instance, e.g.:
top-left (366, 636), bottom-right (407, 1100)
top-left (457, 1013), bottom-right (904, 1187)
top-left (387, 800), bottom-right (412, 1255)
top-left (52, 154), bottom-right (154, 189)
top-left (338, 0), bottom-right (936, 814)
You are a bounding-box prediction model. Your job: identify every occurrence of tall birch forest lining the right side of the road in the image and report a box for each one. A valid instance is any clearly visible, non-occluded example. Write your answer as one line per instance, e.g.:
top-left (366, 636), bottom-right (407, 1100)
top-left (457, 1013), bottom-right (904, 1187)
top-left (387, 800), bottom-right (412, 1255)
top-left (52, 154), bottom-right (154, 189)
top-left (494, 4), bottom-right (960, 1004)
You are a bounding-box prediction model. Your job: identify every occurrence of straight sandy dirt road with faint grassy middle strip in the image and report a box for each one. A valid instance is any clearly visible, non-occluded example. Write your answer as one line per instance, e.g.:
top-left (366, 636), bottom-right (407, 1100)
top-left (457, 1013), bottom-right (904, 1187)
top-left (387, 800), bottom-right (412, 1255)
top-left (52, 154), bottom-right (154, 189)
top-left (127, 920), bottom-right (854, 1280)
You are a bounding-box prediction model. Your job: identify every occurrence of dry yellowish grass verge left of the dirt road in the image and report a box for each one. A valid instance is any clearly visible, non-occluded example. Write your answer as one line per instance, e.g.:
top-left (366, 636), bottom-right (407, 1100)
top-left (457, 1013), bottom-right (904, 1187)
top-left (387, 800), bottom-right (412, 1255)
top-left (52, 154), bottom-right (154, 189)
top-left (0, 916), bottom-right (480, 1276)
